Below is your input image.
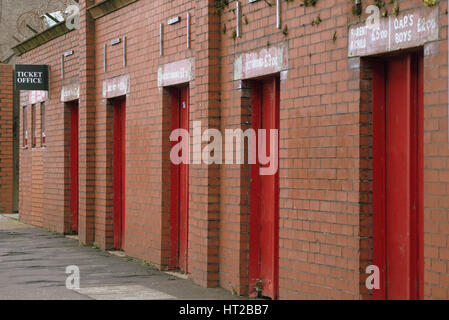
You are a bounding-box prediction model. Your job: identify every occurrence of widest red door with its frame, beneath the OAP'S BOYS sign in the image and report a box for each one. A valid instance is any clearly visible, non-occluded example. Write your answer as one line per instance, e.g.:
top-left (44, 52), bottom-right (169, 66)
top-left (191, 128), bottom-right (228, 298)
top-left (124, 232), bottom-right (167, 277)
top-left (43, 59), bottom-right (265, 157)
top-left (373, 54), bottom-right (424, 300)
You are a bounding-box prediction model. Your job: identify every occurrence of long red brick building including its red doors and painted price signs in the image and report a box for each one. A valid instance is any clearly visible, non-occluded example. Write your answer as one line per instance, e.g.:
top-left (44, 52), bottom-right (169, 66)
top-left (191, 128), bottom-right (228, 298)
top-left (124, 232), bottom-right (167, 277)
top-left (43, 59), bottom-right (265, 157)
top-left (7, 0), bottom-right (449, 299)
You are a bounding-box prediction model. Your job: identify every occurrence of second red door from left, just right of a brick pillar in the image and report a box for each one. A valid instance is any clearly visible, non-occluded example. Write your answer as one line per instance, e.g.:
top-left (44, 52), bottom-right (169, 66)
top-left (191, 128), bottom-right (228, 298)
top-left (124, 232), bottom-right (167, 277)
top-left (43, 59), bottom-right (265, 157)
top-left (113, 98), bottom-right (126, 249)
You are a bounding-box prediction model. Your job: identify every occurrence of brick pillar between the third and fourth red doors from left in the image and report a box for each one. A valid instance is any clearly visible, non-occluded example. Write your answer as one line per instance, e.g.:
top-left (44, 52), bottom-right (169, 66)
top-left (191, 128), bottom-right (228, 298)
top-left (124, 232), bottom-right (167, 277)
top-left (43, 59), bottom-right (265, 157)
top-left (189, 0), bottom-right (220, 287)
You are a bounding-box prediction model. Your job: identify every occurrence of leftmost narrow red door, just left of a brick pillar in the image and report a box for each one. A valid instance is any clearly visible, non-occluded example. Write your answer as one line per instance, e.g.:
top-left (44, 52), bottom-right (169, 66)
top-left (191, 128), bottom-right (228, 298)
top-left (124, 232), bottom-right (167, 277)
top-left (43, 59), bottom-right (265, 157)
top-left (70, 101), bottom-right (79, 234)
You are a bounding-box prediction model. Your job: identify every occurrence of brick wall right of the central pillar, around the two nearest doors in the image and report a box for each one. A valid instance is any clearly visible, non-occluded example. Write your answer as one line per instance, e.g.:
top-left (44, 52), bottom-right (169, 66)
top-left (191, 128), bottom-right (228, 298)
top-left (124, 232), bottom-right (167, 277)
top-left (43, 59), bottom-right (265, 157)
top-left (214, 1), bottom-right (449, 299)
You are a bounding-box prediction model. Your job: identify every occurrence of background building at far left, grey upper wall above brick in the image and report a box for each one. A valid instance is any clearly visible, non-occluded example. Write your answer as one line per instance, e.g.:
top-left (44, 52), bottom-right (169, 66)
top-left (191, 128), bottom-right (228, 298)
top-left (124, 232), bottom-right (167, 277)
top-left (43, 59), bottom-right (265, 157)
top-left (0, 0), bottom-right (78, 213)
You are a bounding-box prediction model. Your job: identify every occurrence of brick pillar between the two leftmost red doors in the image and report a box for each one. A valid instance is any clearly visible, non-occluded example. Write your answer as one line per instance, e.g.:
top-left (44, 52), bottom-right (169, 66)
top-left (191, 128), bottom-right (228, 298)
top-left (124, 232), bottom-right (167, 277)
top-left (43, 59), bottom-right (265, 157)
top-left (78, 0), bottom-right (95, 244)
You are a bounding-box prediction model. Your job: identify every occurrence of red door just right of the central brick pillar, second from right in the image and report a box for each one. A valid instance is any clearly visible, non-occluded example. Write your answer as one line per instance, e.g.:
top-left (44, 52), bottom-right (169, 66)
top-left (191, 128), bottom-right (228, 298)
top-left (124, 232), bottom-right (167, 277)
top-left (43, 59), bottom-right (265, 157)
top-left (249, 78), bottom-right (279, 299)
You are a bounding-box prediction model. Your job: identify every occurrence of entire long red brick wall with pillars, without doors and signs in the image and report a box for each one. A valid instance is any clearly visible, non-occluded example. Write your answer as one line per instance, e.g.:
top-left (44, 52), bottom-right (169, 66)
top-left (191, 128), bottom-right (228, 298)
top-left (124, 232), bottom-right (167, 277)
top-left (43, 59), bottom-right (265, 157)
top-left (14, 0), bottom-right (449, 299)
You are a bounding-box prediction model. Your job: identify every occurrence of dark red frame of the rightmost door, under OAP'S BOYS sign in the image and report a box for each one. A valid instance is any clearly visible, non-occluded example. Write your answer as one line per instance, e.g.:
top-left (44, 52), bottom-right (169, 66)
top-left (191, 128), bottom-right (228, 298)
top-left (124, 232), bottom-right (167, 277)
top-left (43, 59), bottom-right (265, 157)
top-left (372, 53), bottom-right (424, 300)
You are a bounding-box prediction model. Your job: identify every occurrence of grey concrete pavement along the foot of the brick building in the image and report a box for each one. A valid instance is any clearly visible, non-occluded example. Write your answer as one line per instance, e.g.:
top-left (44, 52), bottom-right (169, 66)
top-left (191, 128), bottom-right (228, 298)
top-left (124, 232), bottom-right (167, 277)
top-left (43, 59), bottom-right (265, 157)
top-left (0, 215), bottom-right (242, 300)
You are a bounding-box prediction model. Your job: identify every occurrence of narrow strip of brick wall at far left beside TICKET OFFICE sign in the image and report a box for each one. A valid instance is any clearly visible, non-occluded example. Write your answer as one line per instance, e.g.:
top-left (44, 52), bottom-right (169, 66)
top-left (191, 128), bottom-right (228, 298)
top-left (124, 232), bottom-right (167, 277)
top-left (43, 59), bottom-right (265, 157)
top-left (0, 64), bottom-right (13, 213)
